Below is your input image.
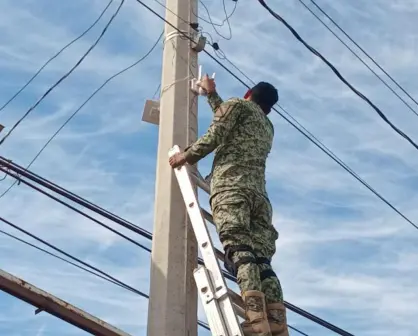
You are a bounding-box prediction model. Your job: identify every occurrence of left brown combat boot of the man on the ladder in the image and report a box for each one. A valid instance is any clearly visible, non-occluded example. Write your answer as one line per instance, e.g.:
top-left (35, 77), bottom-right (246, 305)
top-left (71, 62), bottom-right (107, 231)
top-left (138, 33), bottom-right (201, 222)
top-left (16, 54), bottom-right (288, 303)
top-left (241, 291), bottom-right (271, 336)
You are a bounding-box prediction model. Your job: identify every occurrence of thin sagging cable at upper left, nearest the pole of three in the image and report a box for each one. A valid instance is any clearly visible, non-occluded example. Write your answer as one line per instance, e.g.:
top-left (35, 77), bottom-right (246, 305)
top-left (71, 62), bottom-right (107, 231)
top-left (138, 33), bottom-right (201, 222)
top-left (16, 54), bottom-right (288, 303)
top-left (0, 32), bottom-right (164, 198)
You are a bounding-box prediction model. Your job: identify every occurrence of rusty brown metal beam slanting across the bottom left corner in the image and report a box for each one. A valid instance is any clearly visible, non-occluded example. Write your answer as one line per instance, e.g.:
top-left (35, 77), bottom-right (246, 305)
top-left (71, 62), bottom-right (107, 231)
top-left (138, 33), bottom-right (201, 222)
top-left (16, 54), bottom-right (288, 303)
top-left (0, 270), bottom-right (130, 336)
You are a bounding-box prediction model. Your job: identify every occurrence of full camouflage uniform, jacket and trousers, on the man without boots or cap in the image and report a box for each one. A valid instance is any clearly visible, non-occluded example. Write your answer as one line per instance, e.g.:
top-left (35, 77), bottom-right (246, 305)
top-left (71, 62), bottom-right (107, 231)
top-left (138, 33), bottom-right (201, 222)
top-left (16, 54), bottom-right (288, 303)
top-left (185, 93), bottom-right (283, 303)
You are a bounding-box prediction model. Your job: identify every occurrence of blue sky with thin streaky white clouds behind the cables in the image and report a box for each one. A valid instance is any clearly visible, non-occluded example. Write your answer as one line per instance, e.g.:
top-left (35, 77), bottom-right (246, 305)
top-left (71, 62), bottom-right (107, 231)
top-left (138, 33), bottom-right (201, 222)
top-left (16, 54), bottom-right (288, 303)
top-left (0, 0), bottom-right (418, 336)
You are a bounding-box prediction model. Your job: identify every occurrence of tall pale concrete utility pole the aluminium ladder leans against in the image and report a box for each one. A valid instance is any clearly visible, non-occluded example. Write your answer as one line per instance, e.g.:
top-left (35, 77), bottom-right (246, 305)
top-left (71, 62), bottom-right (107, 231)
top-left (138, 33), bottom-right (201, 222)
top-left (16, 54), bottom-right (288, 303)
top-left (147, 0), bottom-right (197, 336)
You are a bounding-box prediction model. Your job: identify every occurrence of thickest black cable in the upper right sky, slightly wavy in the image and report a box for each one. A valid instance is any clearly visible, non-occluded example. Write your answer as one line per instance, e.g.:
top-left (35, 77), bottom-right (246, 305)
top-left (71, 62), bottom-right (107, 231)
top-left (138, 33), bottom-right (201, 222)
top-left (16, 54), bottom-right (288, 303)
top-left (258, 0), bottom-right (418, 149)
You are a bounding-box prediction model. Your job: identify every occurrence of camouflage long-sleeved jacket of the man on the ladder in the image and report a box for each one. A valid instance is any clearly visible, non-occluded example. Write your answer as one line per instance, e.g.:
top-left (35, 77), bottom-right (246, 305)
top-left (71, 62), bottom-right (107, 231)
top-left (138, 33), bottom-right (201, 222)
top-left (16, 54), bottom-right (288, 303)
top-left (185, 93), bottom-right (274, 196)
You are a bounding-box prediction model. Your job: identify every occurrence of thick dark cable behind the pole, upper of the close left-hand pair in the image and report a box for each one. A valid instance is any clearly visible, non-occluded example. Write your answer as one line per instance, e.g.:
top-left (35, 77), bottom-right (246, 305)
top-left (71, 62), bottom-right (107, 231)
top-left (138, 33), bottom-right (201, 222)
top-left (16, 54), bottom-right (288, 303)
top-left (0, 157), bottom-right (340, 336)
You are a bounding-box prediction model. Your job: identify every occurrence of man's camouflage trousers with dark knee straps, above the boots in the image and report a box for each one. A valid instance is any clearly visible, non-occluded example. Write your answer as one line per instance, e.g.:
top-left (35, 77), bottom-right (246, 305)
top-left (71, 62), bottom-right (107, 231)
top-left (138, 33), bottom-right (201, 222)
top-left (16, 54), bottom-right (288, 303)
top-left (210, 190), bottom-right (283, 304)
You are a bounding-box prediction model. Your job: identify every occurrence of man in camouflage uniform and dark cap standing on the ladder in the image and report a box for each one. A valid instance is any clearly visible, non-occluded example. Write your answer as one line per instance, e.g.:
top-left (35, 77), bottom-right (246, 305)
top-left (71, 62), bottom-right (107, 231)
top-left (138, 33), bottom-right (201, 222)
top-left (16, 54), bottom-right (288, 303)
top-left (169, 75), bottom-right (289, 336)
